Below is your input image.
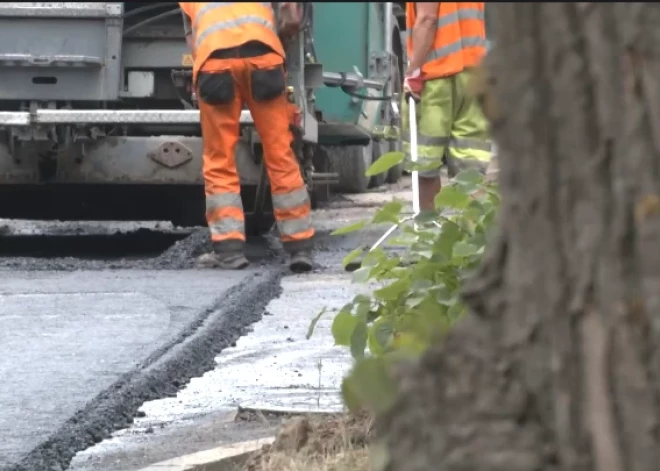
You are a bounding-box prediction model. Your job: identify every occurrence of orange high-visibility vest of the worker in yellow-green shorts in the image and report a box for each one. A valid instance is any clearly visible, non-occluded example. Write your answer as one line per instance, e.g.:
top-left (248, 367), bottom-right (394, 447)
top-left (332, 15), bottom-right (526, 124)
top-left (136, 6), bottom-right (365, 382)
top-left (406, 2), bottom-right (486, 80)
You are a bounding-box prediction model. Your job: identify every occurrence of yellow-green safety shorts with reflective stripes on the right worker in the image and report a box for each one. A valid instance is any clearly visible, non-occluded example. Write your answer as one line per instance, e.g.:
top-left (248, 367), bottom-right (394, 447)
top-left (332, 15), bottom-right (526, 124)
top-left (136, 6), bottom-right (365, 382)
top-left (401, 69), bottom-right (491, 178)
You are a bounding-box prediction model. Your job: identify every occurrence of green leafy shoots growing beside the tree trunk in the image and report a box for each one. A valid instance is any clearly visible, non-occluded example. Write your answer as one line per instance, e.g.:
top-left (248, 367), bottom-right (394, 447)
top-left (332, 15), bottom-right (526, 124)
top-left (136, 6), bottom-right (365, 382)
top-left (310, 168), bottom-right (499, 412)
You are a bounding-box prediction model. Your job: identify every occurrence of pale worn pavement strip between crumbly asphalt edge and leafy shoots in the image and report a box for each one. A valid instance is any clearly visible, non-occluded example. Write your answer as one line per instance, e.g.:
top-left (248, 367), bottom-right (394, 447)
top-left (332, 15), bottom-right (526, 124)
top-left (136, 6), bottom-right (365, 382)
top-left (70, 187), bottom-right (416, 471)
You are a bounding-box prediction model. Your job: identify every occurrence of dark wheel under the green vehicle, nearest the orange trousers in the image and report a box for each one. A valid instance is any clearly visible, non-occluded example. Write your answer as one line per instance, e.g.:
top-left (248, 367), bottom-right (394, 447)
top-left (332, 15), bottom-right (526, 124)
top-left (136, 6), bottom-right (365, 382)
top-left (327, 143), bottom-right (373, 193)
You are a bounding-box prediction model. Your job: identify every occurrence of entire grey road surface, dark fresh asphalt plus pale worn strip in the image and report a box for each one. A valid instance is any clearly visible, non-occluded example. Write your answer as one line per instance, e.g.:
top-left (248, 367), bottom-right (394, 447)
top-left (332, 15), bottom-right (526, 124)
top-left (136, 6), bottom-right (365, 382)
top-left (0, 179), bottom-right (412, 471)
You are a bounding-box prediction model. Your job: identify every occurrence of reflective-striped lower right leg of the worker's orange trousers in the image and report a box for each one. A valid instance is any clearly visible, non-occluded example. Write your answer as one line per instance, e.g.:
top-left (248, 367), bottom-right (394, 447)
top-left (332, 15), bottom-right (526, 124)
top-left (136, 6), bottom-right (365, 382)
top-left (272, 186), bottom-right (312, 241)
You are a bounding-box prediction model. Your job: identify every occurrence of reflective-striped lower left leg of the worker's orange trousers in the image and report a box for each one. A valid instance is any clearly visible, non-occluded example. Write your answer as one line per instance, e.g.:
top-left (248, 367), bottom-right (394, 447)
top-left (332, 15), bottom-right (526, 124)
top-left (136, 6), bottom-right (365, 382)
top-left (206, 193), bottom-right (245, 242)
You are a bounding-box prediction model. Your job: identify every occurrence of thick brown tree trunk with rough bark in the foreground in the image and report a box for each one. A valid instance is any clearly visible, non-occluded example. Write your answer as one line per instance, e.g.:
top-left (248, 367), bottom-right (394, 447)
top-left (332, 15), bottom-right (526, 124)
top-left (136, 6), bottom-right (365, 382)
top-left (382, 2), bottom-right (660, 471)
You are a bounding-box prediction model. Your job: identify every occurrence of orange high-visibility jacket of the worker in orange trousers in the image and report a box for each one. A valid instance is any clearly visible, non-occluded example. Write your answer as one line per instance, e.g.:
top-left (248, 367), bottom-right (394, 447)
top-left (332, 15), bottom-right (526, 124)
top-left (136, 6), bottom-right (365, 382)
top-left (179, 2), bottom-right (285, 83)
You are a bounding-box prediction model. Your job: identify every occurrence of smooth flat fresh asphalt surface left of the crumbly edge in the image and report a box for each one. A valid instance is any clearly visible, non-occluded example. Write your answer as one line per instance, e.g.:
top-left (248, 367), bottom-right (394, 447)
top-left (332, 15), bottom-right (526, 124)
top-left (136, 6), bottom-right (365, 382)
top-left (0, 271), bottom-right (268, 465)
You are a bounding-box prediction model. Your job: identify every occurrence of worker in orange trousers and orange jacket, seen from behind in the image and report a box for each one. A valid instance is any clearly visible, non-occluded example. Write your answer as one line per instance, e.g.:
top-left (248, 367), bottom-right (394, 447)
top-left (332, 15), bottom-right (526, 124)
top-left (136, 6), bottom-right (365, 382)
top-left (179, 2), bottom-right (314, 272)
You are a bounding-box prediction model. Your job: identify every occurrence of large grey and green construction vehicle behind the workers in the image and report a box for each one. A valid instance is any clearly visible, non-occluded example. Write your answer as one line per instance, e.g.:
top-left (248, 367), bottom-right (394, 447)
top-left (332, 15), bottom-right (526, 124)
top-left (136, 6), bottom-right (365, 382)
top-left (0, 2), bottom-right (405, 230)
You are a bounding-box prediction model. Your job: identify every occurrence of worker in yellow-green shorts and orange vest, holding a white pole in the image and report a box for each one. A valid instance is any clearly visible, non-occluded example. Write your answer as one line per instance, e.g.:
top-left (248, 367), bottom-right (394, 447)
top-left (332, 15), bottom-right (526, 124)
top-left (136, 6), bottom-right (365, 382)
top-left (402, 2), bottom-right (490, 210)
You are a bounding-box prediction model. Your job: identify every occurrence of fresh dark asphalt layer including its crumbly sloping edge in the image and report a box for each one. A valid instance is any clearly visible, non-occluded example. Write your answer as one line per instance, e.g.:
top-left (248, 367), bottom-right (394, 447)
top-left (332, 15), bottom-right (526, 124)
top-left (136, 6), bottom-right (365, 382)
top-left (0, 227), bottom-right (281, 470)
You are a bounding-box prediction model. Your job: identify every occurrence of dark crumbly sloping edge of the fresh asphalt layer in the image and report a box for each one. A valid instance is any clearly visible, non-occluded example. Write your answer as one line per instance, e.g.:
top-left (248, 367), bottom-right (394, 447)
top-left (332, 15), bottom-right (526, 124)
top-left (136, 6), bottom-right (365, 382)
top-left (4, 266), bottom-right (283, 471)
